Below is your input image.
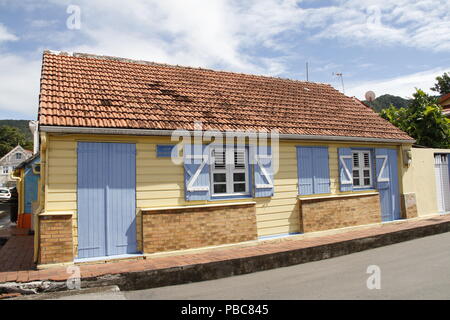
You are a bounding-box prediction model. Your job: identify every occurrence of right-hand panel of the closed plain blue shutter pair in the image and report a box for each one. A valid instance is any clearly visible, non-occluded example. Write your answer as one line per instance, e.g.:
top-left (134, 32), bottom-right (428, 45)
top-left (311, 147), bottom-right (330, 194)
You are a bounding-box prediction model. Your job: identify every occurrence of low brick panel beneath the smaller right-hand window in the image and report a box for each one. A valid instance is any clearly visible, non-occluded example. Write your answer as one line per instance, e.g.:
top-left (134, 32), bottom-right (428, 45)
top-left (300, 194), bottom-right (381, 232)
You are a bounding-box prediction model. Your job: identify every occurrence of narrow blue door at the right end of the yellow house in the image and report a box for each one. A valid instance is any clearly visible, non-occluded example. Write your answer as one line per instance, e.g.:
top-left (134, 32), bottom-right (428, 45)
top-left (375, 148), bottom-right (400, 221)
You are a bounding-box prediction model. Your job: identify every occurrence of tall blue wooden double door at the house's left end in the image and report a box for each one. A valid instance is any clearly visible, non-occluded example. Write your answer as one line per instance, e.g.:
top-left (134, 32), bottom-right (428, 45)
top-left (77, 142), bottom-right (137, 258)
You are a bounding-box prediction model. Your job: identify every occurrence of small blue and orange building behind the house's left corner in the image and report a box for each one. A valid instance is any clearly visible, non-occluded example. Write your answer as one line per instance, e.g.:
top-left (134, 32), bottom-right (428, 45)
top-left (13, 153), bottom-right (40, 229)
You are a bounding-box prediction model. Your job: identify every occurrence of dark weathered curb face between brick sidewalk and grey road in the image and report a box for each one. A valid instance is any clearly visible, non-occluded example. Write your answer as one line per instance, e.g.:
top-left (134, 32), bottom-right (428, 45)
top-left (0, 221), bottom-right (450, 292)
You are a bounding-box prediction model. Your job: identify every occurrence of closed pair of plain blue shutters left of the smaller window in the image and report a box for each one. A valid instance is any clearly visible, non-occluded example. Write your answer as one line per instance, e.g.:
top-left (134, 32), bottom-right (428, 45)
top-left (297, 147), bottom-right (330, 195)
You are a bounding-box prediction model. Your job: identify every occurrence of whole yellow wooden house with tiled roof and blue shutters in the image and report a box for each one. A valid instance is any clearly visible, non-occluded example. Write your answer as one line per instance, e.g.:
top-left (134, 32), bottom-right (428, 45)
top-left (35, 52), bottom-right (417, 264)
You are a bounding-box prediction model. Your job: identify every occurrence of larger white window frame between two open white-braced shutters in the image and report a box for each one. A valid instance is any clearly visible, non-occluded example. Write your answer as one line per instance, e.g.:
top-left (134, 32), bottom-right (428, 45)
top-left (210, 145), bottom-right (250, 197)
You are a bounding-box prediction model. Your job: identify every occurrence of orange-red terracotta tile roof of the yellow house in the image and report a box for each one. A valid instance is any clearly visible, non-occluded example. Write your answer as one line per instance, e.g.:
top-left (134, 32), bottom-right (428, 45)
top-left (39, 51), bottom-right (412, 140)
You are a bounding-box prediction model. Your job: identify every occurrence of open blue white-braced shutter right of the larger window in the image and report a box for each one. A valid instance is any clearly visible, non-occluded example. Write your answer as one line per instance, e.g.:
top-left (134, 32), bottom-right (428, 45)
top-left (251, 146), bottom-right (273, 198)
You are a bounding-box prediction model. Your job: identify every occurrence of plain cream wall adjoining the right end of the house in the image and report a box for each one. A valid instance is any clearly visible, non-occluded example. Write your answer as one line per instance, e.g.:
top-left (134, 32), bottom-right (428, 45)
top-left (402, 148), bottom-right (450, 216)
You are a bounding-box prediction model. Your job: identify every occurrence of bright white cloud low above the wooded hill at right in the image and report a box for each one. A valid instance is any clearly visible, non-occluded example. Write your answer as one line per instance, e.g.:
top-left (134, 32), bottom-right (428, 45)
top-left (346, 66), bottom-right (450, 100)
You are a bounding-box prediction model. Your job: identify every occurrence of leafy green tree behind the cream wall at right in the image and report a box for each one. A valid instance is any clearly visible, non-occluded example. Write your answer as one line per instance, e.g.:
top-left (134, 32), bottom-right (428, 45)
top-left (380, 89), bottom-right (450, 148)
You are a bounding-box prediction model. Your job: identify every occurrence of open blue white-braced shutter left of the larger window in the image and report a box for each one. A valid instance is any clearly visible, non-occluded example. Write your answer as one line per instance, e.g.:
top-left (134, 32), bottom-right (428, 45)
top-left (183, 145), bottom-right (210, 201)
